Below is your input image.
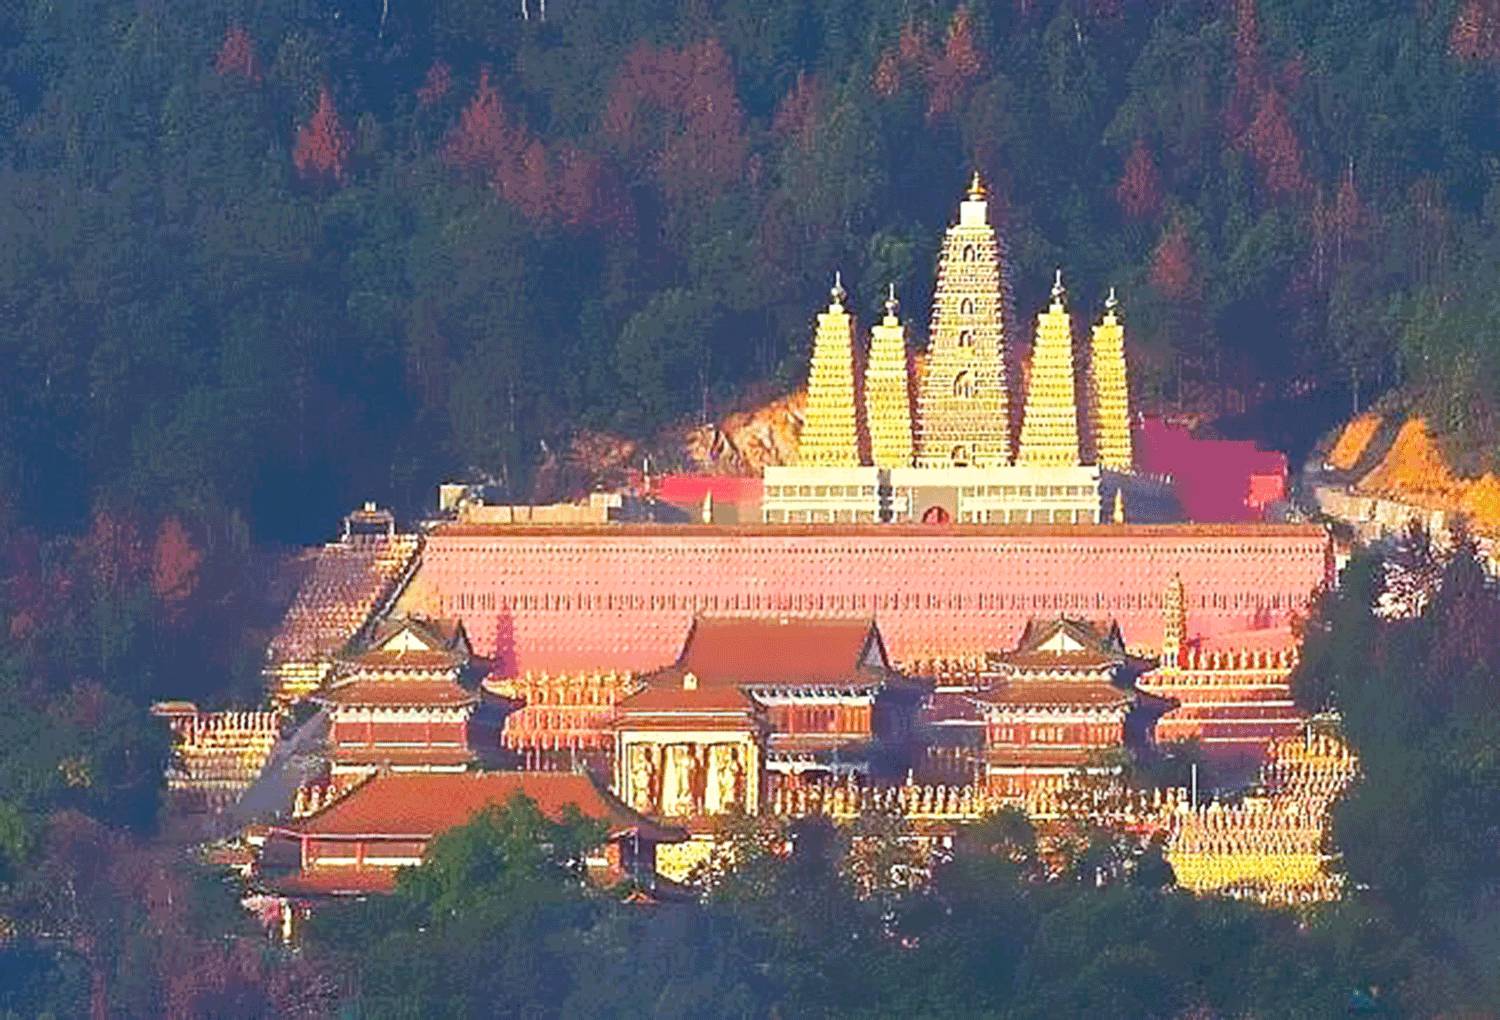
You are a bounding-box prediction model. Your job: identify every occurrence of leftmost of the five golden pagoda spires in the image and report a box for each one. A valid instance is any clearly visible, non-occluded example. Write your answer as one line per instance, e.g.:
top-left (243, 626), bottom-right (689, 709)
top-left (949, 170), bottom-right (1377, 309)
top-left (798, 273), bottom-right (860, 468)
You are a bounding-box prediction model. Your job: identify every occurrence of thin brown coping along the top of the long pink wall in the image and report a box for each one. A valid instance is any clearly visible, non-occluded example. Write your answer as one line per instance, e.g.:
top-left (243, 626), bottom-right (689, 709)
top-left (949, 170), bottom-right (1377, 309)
top-left (432, 522), bottom-right (1328, 539)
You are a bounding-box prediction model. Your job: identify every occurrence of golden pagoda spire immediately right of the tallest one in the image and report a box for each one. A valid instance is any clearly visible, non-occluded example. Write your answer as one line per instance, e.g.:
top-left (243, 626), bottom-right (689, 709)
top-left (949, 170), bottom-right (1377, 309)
top-left (1016, 269), bottom-right (1080, 468)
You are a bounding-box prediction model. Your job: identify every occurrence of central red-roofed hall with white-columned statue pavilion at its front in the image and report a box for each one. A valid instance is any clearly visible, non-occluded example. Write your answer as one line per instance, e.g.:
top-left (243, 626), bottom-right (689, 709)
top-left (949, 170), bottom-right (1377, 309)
top-left (615, 617), bottom-right (921, 815)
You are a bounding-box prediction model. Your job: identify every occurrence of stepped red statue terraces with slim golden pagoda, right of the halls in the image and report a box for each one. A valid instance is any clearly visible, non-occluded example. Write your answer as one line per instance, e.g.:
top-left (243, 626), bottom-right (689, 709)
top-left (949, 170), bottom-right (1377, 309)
top-left (1136, 578), bottom-right (1304, 773)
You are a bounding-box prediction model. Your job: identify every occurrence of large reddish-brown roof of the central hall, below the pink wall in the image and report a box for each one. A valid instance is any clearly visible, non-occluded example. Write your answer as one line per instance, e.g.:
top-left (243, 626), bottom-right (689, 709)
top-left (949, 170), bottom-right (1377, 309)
top-left (668, 617), bottom-right (890, 686)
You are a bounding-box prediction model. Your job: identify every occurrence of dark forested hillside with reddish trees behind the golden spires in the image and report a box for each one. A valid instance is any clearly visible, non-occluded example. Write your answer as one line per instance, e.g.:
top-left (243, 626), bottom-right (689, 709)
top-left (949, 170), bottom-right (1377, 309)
top-left (0, 0), bottom-right (1500, 540)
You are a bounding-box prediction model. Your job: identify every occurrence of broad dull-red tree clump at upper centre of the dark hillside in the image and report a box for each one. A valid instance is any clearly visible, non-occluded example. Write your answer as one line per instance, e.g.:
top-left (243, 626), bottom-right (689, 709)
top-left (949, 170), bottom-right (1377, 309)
top-left (603, 39), bottom-right (747, 198)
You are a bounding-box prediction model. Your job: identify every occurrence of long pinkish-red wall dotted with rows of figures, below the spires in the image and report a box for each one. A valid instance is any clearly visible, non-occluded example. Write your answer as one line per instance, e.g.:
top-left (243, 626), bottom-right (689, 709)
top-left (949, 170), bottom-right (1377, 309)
top-left (416, 525), bottom-right (1331, 674)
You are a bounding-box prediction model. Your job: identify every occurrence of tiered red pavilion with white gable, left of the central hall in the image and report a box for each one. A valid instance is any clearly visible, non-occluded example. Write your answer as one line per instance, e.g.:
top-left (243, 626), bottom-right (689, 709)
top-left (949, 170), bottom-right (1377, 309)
top-left (317, 618), bottom-right (479, 776)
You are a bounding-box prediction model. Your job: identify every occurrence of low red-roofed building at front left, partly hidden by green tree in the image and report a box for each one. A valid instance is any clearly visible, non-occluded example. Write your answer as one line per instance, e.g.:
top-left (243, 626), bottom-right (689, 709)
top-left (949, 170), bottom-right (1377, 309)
top-left (261, 770), bottom-right (686, 899)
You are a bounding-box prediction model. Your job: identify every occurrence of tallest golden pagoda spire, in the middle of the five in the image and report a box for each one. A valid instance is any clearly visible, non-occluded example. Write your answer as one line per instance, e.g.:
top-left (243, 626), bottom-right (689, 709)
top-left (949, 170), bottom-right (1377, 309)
top-left (915, 173), bottom-right (1011, 468)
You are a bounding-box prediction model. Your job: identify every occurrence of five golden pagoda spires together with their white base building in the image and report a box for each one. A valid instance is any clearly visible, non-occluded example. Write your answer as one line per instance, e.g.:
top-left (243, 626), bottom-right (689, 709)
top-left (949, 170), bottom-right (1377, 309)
top-left (761, 176), bottom-right (1140, 524)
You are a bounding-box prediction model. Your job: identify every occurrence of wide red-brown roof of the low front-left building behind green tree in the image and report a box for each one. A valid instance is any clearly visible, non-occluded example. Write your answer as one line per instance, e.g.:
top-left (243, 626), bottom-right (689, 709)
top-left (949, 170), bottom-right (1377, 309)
top-left (293, 773), bottom-right (683, 843)
